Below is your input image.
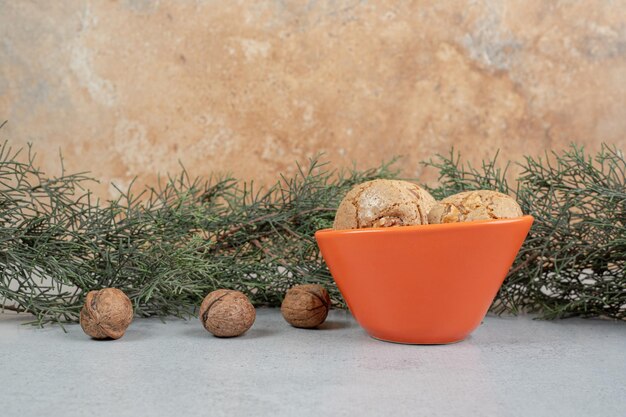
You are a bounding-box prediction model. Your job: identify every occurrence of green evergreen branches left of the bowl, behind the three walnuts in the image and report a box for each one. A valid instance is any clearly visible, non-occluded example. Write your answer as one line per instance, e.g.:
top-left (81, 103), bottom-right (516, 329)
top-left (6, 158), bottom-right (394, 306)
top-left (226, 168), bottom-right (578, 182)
top-left (0, 142), bottom-right (397, 325)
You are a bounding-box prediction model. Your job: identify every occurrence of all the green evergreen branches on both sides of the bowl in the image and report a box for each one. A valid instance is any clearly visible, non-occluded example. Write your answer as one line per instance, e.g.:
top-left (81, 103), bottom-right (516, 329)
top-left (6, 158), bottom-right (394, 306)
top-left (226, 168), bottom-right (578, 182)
top-left (0, 135), bottom-right (626, 325)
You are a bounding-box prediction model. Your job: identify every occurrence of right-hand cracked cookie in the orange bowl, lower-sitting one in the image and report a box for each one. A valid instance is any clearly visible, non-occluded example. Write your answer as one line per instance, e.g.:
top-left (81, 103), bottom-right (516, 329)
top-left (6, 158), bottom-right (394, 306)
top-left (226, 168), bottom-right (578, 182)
top-left (428, 190), bottom-right (523, 224)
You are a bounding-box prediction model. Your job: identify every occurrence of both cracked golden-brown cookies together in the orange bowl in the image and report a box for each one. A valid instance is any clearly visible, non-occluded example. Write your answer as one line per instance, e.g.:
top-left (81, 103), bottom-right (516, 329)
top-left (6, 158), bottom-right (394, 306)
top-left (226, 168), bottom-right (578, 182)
top-left (333, 179), bottom-right (522, 230)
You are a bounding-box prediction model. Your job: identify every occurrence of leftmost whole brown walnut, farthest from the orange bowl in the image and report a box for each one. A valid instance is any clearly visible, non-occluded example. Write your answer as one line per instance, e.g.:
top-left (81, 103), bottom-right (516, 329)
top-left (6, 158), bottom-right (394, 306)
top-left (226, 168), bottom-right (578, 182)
top-left (80, 288), bottom-right (133, 339)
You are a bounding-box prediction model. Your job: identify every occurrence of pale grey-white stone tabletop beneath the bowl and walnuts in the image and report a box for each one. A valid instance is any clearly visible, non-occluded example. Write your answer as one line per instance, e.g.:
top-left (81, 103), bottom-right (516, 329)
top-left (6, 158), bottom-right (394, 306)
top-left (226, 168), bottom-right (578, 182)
top-left (0, 309), bottom-right (626, 417)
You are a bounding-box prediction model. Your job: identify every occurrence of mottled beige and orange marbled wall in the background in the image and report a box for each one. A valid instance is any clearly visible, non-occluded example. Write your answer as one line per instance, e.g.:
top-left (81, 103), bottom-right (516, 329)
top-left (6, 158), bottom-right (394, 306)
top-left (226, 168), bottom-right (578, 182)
top-left (0, 0), bottom-right (626, 195)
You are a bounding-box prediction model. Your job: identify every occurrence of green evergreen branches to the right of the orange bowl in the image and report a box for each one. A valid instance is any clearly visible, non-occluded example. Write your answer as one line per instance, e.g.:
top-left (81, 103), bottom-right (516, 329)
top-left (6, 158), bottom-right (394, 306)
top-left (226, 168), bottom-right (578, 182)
top-left (425, 145), bottom-right (626, 320)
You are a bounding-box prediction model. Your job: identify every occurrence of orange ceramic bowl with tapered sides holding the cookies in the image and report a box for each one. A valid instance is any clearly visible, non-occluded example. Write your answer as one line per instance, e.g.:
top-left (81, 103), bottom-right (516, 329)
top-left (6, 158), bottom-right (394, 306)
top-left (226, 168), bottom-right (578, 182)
top-left (315, 216), bottom-right (533, 344)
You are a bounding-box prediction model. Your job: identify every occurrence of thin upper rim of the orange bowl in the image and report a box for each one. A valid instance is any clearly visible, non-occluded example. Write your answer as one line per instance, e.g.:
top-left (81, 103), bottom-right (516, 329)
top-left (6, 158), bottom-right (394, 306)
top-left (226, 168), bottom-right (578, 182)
top-left (315, 214), bottom-right (534, 236)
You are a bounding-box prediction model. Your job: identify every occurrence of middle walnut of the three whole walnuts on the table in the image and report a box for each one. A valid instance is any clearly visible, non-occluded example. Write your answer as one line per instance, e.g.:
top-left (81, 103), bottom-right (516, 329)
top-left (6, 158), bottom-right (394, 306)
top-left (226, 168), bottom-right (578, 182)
top-left (200, 290), bottom-right (256, 337)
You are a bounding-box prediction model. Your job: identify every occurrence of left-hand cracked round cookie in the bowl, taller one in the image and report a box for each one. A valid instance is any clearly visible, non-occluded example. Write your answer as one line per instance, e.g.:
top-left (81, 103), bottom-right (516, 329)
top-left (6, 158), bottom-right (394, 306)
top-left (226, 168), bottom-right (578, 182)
top-left (333, 180), bottom-right (435, 229)
